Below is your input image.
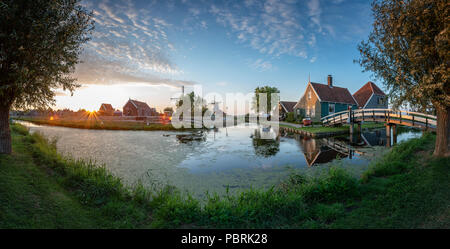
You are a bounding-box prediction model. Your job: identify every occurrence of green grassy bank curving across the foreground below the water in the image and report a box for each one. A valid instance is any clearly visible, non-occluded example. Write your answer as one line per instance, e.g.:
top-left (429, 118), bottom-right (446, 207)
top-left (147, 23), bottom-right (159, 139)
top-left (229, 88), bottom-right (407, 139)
top-left (0, 125), bottom-right (450, 228)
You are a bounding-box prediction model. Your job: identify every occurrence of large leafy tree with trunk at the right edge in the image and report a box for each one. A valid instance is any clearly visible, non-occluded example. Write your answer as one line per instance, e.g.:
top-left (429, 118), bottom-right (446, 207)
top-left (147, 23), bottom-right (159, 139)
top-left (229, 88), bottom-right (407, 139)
top-left (356, 0), bottom-right (450, 156)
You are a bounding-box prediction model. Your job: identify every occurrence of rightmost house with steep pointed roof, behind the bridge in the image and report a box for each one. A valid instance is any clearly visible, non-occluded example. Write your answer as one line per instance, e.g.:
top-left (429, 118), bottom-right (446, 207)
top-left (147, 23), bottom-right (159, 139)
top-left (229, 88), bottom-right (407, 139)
top-left (353, 81), bottom-right (388, 109)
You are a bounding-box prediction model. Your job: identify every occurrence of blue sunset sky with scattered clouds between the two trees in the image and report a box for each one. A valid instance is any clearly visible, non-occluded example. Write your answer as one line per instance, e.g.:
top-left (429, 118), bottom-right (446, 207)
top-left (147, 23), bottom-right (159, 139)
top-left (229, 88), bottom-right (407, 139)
top-left (55, 0), bottom-right (376, 113)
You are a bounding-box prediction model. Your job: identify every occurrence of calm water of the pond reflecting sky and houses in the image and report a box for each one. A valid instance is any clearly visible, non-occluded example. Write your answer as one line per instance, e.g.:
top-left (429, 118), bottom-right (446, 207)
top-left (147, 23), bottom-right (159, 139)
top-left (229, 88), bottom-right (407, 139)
top-left (15, 122), bottom-right (420, 197)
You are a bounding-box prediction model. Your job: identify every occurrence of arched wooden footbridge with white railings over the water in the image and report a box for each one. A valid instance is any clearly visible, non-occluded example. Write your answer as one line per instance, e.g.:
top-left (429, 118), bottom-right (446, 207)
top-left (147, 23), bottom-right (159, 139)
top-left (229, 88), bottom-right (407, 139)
top-left (321, 109), bottom-right (437, 132)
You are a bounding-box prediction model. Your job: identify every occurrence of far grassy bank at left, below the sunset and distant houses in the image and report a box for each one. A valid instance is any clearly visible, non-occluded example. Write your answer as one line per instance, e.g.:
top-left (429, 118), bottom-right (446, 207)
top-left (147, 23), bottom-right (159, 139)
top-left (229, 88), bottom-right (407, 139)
top-left (14, 117), bottom-right (194, 131)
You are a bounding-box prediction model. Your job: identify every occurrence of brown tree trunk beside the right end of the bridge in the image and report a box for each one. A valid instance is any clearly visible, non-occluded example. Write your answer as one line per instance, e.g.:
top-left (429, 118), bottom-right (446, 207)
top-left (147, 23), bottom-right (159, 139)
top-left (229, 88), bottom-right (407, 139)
top-left (433, 105), bottom-right (450, 157)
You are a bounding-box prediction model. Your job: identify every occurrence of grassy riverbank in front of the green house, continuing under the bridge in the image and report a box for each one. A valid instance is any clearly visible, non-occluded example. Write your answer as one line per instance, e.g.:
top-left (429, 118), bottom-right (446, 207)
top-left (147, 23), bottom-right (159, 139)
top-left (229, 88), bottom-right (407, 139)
top-left (280, 122), bottom-right (384, 137)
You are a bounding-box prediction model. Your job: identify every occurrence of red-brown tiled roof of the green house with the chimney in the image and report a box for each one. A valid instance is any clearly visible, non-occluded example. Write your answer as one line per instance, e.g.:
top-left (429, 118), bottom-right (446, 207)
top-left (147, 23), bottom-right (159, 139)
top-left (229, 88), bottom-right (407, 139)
top-left (311, 82), bottom-right (357, 105)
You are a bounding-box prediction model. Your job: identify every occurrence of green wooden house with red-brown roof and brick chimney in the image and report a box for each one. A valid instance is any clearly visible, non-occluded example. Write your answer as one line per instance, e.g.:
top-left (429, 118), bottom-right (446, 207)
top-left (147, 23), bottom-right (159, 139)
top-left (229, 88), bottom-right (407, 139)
top-left (294, 75), bottom-right (358, 122)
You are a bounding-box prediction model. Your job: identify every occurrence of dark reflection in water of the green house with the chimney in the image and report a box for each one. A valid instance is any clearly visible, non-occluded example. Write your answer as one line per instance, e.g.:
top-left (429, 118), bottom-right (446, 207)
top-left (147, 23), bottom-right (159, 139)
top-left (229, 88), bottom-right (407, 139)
top-left (297, 137), bottom-right (352, 166)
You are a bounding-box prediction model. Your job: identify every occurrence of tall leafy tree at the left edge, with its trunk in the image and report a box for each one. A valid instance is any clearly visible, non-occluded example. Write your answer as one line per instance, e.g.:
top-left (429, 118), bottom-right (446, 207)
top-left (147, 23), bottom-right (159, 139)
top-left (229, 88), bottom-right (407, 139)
top-left (0, 0), bottom-right (94, 153)
